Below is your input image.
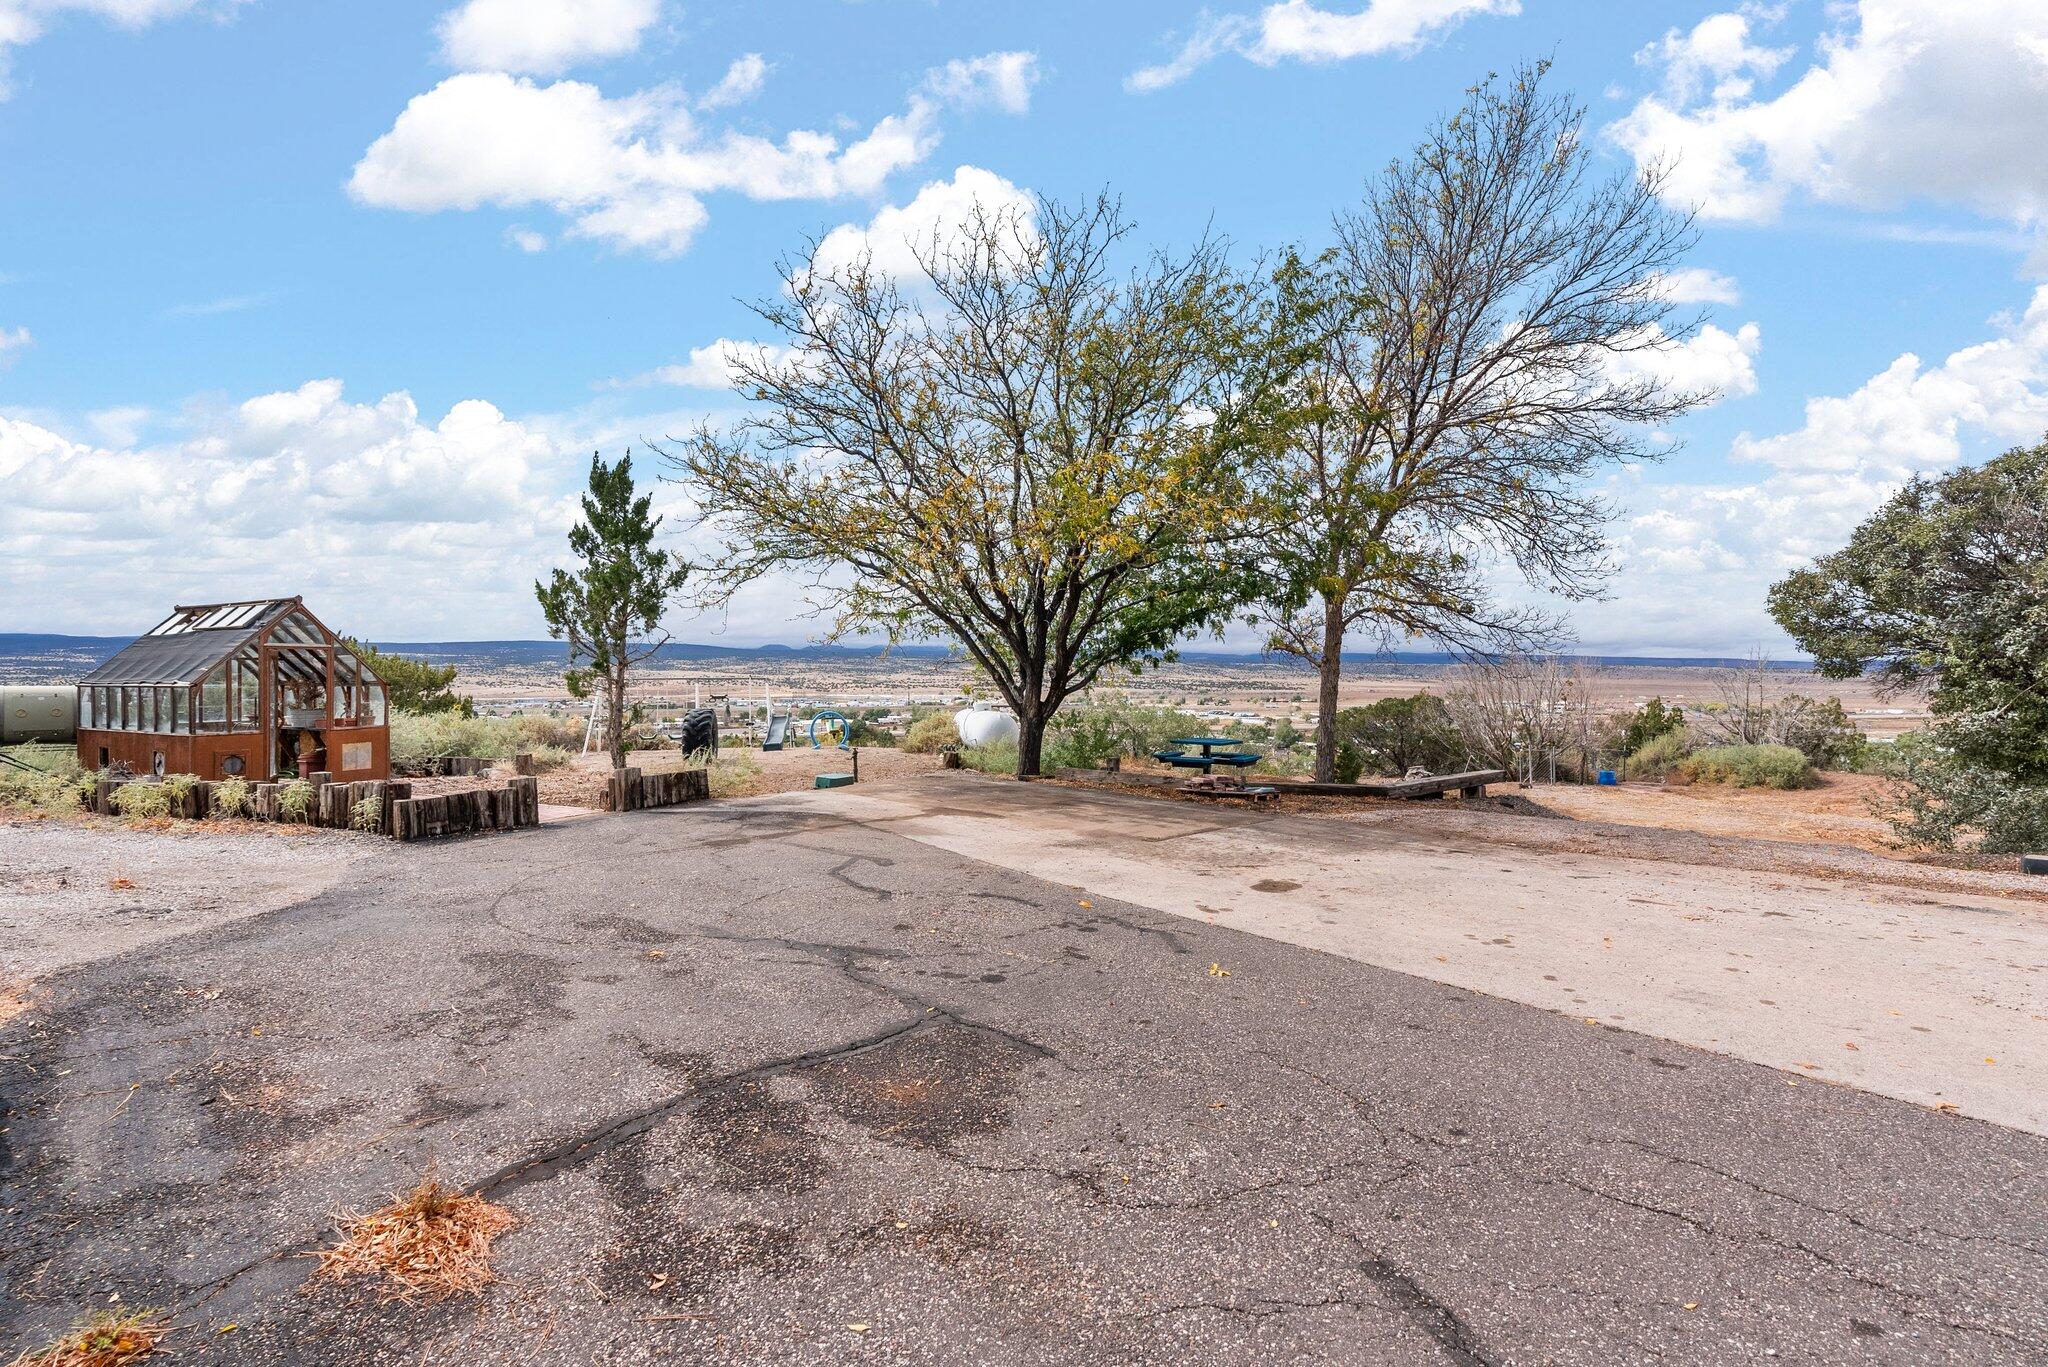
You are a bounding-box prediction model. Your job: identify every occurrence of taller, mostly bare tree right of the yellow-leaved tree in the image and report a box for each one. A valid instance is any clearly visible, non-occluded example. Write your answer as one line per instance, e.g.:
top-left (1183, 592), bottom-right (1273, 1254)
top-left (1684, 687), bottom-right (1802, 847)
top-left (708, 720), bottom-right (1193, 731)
top-left (1255, 66), bottom-right (1710, 779)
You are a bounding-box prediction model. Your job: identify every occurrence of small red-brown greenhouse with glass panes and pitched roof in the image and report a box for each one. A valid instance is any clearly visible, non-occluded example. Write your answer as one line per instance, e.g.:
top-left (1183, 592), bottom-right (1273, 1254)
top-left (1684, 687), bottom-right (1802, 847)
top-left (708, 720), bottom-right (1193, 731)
top-left (78, 598), bottom-right (391, 781)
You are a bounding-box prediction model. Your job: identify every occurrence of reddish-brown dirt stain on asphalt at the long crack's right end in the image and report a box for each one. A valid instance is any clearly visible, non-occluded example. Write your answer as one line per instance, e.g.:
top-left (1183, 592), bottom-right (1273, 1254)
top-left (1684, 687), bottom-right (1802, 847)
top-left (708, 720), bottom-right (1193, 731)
top-left (809, 1025), bottom-right (1032, 1150)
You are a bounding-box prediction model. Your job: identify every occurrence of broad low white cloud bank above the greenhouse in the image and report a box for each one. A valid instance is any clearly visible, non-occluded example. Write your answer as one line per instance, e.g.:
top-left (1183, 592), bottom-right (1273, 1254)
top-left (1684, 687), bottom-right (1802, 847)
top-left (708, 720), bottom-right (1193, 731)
top-left (0, 381), bottom-right (588, 639)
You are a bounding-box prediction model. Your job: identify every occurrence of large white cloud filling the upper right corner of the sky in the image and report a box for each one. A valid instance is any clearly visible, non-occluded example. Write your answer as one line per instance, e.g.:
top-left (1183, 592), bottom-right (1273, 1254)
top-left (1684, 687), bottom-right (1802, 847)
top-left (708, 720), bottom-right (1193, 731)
top-left (1610, 0), bottom-right (2048, 225)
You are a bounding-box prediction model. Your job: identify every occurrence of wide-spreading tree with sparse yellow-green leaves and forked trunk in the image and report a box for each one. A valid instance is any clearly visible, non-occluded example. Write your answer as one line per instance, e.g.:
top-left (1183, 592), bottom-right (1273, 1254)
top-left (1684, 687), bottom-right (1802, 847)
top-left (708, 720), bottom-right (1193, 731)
top-left (668, 199), bottom-right (1305, 777)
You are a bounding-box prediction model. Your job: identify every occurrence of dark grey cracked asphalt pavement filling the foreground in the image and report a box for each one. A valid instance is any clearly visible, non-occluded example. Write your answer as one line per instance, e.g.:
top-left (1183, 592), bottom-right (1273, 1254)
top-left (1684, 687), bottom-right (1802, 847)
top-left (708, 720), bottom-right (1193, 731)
top-left (0, 786), bottom-right (2048, 1365)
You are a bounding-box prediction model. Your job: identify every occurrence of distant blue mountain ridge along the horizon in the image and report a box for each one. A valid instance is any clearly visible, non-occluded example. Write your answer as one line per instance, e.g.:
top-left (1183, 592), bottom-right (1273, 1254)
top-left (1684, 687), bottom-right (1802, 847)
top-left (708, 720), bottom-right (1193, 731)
top-left (0, 631), bottom-right (1812, 672)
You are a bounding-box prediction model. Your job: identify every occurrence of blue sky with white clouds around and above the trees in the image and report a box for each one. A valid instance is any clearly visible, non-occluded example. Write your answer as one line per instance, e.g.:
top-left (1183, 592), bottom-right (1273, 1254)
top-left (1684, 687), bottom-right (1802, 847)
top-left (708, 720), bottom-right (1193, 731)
top-left (0, 0), bottom-right (2048, 654)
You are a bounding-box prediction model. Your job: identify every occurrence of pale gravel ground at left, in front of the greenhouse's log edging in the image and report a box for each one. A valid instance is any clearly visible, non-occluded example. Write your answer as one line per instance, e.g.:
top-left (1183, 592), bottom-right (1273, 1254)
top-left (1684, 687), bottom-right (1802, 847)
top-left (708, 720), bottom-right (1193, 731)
top-left (0, 818), bottom-right (389, 987)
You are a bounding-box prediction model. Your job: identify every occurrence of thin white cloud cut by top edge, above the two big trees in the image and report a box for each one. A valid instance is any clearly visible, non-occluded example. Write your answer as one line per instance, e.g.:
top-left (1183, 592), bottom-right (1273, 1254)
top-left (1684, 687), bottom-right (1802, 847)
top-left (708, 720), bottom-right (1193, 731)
top-left (1124, 0), bottom-right (1522, 94)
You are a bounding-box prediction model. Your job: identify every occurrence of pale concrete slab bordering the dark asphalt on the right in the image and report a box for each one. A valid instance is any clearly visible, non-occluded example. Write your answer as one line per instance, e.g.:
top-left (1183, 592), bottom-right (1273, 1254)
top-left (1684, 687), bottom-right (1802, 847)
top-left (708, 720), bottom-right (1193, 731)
top-left (762, 775), bottom-right (2048, 1133)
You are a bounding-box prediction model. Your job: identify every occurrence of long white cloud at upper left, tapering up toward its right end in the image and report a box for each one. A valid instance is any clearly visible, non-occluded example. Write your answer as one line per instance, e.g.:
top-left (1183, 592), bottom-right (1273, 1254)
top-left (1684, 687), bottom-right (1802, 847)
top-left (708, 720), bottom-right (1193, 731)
top-left (348, 53), bottom-right (1028, 256)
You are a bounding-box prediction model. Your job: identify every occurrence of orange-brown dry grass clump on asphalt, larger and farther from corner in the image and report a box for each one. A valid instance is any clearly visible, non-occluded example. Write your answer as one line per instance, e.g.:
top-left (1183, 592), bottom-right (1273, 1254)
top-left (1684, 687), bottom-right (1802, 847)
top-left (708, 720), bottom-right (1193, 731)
top-left (315, 1176), bottom-right (518, 1303)
